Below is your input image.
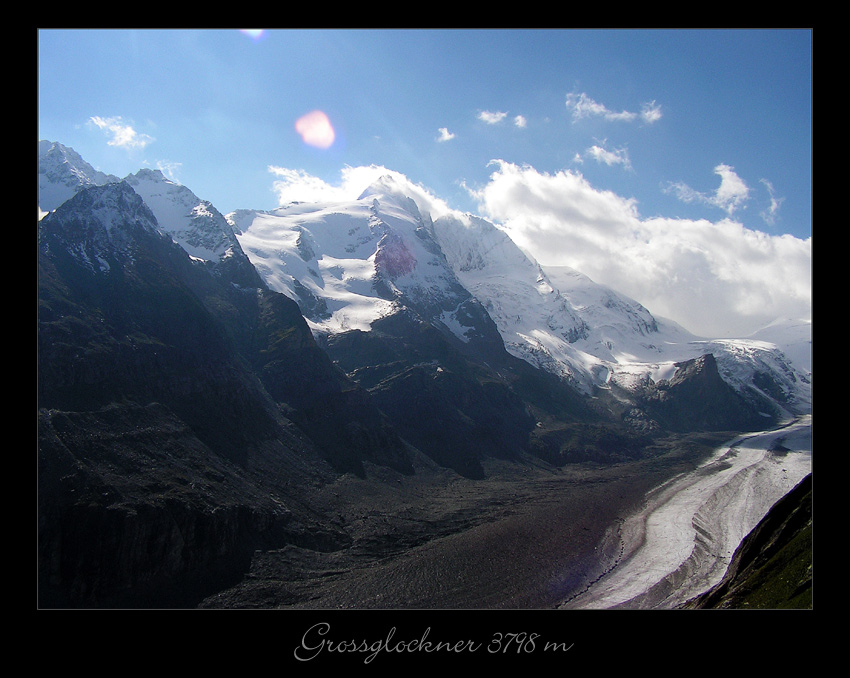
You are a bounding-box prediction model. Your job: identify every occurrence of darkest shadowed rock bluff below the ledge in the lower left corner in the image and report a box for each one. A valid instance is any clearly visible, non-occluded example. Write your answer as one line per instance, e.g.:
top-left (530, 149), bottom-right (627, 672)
top-left (39, 404), bottom-right (298, 607)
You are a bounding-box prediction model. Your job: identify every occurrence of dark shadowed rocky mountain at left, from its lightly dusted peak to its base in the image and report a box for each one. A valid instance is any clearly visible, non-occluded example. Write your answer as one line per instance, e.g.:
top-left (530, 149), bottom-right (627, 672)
top-left (38, 183), bottom-right (409, 607)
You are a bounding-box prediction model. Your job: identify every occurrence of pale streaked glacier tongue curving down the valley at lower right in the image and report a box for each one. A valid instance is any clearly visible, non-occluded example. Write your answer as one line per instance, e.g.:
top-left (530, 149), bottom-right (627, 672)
top-left (561, 415), bottom-right (812, 609)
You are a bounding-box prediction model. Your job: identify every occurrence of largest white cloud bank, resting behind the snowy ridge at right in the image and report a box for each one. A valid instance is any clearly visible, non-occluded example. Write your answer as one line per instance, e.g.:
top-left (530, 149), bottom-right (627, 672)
top-left (471, 161), bottom-right (811, 337)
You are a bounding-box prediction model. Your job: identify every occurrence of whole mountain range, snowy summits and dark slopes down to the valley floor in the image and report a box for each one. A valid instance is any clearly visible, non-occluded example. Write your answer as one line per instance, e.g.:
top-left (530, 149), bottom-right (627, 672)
top-left (38, 144), bottom-right (806, 607)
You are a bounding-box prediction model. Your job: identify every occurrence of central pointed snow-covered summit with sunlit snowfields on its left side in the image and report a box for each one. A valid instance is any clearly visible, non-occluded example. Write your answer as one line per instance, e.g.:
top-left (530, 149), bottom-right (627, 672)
top-left (228, 177), bottom-right (500, 356)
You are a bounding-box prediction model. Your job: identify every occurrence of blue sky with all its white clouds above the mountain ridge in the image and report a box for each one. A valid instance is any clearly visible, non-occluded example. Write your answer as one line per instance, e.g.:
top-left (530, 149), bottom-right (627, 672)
top-left (38, 29), bottom-right (812, 334)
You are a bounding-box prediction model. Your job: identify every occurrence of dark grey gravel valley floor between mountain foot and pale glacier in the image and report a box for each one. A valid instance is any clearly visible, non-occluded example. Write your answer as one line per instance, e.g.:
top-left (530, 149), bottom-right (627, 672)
top-left (195, 434), bottom-right (744, 610)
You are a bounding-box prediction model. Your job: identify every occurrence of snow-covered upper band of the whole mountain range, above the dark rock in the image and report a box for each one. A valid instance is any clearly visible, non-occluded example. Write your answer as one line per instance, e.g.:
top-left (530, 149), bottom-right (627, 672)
top-left (39, 142), bottom-right (811, 422)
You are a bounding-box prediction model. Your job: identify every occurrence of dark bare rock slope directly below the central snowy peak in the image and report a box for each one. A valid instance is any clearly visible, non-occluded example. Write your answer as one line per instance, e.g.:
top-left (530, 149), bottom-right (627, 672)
top-left (318, 312), bottom-right (600, 478)
